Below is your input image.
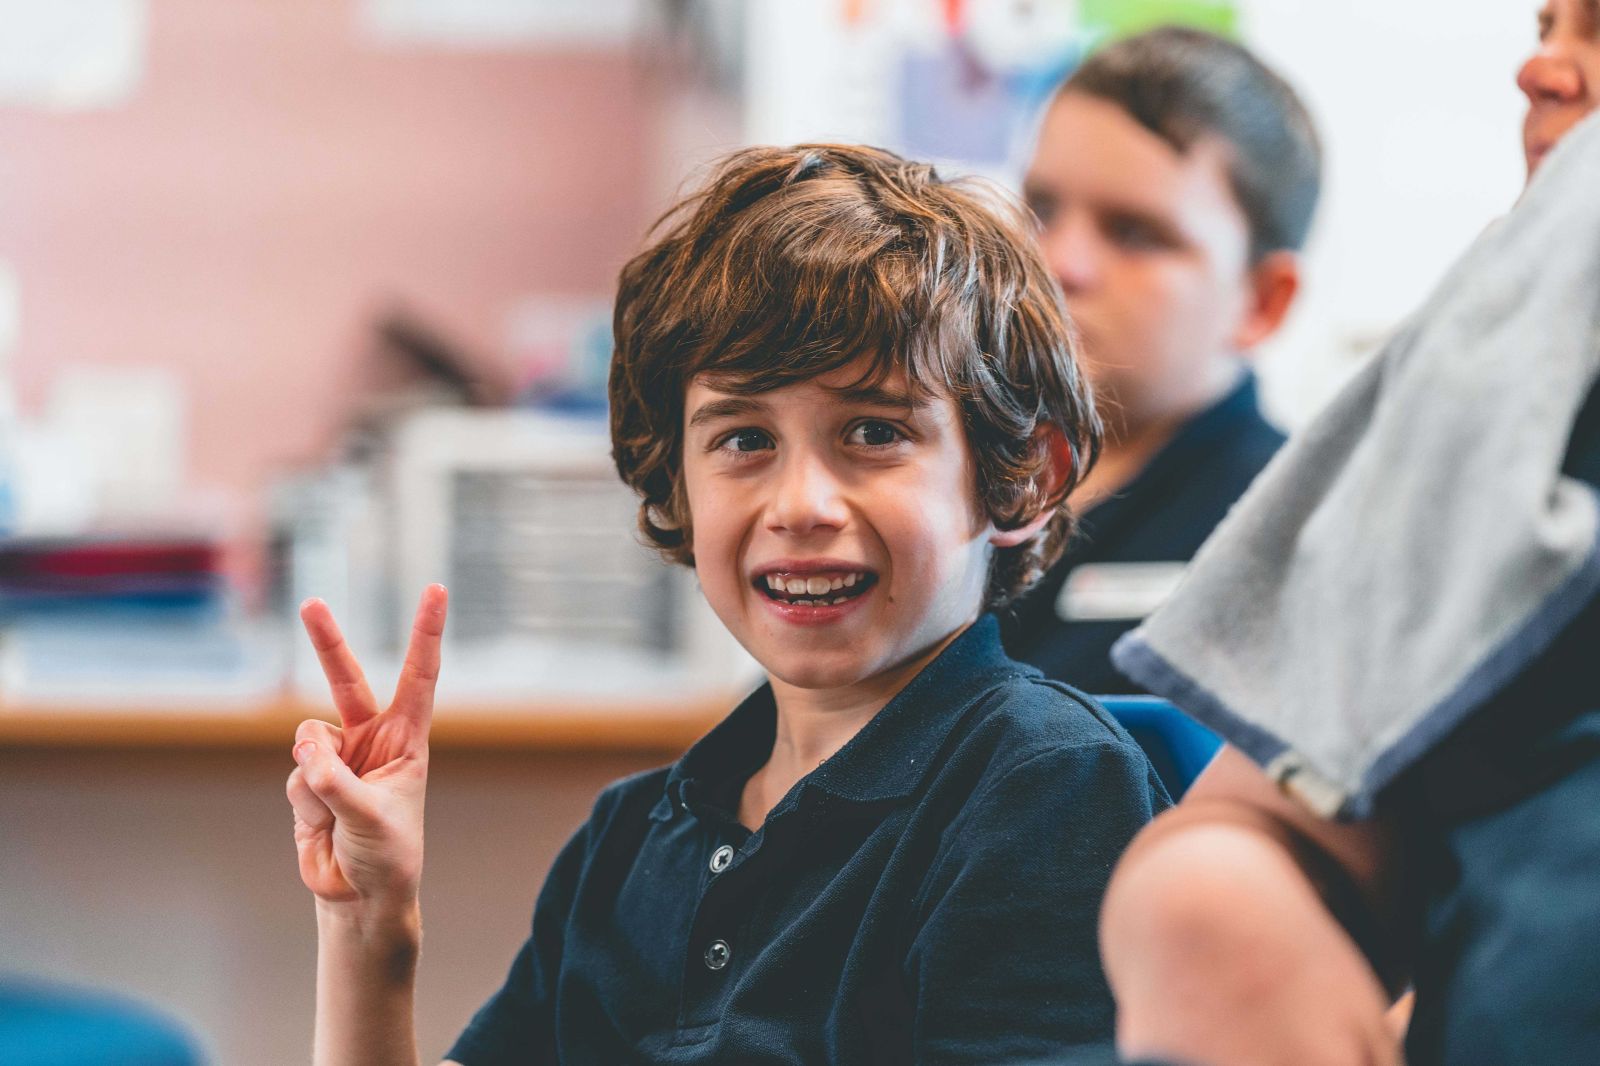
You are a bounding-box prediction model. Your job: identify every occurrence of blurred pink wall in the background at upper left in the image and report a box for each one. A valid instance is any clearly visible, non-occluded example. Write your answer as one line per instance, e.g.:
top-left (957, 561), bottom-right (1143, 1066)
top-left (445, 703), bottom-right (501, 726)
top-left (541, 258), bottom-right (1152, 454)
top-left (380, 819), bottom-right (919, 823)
top-left (0, 0), bottom-right (653, 511)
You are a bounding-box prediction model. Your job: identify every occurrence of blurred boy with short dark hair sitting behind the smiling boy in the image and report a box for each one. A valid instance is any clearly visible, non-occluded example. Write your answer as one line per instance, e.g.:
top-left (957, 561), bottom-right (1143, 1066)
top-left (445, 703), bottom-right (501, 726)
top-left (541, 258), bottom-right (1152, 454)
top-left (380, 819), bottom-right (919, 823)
top-left (1005, 27), bottom-right (1322, 693)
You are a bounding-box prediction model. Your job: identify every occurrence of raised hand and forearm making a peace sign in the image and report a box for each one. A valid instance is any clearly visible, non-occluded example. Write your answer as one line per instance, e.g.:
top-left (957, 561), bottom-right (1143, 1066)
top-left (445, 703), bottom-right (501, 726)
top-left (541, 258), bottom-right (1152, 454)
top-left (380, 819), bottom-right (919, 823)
top-left (286, 586), bottom-right (446, 1066)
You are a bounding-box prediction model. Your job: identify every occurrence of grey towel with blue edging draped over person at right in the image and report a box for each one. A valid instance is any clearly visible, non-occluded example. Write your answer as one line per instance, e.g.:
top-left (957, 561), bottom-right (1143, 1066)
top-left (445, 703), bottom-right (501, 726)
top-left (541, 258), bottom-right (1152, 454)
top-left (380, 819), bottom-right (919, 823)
top-left (1112, 115), bottom-right (1600, 818)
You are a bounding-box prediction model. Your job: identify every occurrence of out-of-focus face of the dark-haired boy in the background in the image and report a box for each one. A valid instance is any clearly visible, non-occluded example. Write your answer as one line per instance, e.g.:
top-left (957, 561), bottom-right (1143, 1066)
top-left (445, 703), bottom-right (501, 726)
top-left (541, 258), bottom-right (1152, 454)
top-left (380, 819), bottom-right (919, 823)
top-left (1022, 93), bottom-right (1251, 427)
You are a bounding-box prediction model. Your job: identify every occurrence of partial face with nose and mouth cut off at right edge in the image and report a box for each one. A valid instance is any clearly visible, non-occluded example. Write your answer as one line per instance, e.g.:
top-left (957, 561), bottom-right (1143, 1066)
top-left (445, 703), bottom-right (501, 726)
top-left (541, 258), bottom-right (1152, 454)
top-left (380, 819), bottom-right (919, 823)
top-left (1517, 0), bottom-right (1600, 176)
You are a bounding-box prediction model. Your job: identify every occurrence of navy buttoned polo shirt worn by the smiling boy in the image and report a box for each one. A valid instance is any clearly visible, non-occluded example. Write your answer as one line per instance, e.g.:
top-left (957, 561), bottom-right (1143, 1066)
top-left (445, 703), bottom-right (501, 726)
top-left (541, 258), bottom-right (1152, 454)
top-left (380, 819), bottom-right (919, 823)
top-left (450, 616), bottom-right (1168, 1066)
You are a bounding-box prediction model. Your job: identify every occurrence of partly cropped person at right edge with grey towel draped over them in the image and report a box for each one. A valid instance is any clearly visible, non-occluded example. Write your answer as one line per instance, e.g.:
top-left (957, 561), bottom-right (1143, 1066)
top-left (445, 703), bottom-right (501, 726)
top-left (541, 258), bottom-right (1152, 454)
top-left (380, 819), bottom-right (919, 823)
top-left (1102, 0), bottom-right (1600, 1066)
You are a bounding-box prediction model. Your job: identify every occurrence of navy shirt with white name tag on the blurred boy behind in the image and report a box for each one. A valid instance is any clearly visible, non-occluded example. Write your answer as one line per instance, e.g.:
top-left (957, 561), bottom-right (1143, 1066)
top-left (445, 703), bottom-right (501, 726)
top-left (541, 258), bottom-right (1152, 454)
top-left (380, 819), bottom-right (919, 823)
top-left (1003, 373), bottom-right (1285, 695)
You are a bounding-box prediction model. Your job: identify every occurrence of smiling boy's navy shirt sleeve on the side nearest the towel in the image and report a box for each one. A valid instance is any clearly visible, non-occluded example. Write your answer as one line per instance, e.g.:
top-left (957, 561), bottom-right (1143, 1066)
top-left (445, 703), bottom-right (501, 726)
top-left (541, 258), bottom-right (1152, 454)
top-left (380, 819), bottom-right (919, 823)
top-left (906, 743), bottom-right (1166, 1066)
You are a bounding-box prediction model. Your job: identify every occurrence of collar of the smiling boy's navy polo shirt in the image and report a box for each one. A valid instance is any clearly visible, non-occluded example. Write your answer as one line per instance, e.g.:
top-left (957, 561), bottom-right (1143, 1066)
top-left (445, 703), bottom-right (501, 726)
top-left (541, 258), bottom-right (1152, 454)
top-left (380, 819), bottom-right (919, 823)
top-left (653, 615), bottom-right (1037, 818)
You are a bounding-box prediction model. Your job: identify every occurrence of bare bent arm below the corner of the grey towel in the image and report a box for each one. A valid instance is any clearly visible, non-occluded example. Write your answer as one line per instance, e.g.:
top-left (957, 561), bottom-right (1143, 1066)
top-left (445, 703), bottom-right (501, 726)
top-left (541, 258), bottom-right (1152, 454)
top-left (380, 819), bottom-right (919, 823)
top-left (1101, 747), bottom-right (1405, 1066)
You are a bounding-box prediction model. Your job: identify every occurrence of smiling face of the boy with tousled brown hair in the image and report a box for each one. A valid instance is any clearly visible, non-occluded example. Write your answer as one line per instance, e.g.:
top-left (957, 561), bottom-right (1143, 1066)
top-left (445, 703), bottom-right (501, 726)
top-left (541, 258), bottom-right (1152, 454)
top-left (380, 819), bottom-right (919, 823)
top-left (682, 367), bottom-right (992, 695)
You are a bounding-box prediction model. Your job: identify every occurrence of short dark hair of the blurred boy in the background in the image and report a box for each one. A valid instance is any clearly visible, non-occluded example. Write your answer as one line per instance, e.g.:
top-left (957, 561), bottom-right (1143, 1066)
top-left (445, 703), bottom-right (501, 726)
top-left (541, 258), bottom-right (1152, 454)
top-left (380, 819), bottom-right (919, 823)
top-left (1058, 26), bottom-right (1322, 262)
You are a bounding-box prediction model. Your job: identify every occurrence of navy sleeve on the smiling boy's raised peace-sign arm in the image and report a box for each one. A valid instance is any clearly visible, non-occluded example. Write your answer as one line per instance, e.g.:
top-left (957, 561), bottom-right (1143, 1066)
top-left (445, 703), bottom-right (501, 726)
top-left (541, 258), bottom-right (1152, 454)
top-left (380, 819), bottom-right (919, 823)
top-left (445, 824), bottom-right (590, 1066)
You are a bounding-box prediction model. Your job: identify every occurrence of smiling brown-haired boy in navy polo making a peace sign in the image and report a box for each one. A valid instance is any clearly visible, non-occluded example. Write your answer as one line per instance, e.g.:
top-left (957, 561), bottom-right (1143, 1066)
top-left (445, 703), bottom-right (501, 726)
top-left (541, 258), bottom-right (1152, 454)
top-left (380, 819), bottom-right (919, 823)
top-left (288, 146), bottom-right (1166, 1066)
